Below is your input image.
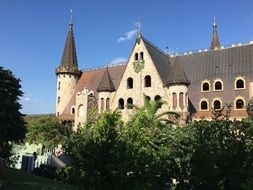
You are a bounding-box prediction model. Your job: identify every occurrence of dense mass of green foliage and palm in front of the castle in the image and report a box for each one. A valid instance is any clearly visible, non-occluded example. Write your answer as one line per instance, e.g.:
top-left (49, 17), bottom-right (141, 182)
top-left (67, 101), bottom-right (253, 190)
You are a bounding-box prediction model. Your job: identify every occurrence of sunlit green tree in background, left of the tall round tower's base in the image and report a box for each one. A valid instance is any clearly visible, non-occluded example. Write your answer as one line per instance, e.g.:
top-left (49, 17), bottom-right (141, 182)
top-left (25, 116), bottom-right (71, 150)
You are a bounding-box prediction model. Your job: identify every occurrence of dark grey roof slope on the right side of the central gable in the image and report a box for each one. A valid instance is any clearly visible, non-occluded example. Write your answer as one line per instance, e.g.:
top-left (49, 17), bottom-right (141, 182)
top-left (141, 36), bottom-right (171, 85)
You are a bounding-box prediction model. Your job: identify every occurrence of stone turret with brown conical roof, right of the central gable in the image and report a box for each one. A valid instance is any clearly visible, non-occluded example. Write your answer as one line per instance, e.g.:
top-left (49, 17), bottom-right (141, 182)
top-left (166, 56), bottom-right (190, 117)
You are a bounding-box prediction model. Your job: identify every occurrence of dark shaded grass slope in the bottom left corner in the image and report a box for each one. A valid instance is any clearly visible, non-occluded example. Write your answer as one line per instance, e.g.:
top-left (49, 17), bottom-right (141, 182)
top-left (0, 167), bottom-right (74, 190)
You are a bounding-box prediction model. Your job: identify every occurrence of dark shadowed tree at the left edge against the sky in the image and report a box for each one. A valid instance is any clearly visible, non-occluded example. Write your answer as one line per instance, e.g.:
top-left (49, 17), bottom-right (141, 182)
top-left (0, 67), bottom-right (25, 160)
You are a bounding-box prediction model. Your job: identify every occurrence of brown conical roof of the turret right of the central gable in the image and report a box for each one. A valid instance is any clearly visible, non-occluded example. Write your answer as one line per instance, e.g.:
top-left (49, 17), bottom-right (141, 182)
top-left (166, 57), bottom-right (190, 86)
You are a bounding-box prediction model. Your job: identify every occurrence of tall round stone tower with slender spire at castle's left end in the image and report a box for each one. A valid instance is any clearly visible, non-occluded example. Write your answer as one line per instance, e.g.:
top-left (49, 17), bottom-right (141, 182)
top-left (55, 15), bottom-right (81, 115)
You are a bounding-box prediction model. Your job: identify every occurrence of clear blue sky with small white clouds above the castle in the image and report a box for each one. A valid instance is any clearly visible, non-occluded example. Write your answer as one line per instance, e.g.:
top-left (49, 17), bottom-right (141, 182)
top-left (0, 0), bottom-right (253, 114)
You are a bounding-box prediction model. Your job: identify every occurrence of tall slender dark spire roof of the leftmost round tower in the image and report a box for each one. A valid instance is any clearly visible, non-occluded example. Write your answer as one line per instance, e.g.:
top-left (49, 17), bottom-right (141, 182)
top-left (55, 18), bottom-right (81, 75)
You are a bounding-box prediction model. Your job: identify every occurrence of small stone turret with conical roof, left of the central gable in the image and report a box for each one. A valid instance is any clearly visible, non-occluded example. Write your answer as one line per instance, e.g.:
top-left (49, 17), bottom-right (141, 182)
top-left (97, 67), bottom-right (115, 113)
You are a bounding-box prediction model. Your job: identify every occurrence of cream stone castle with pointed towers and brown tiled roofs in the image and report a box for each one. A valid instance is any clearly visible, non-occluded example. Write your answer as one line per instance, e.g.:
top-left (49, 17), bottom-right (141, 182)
top-left (55, 17), bottom-right (253, 128)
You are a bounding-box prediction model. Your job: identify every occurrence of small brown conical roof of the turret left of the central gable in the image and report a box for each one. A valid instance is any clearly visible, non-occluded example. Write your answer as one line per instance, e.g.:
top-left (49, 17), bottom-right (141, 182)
top-left (97, 67), bottom-right (115, 92)
